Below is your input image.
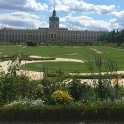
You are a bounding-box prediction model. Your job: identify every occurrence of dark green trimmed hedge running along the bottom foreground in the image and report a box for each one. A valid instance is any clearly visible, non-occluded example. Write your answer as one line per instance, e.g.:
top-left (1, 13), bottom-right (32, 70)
top-left (0, 102), bottom-right (124, 122)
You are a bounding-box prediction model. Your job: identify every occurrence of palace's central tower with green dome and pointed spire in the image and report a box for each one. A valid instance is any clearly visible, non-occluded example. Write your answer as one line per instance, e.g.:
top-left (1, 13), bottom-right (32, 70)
top-left (49, 9), bottom-right (59, 30)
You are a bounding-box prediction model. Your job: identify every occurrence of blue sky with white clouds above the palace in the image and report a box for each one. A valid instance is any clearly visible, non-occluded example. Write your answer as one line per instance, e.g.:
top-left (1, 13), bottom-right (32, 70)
top-left (0, 0), bottom-right (124, 31)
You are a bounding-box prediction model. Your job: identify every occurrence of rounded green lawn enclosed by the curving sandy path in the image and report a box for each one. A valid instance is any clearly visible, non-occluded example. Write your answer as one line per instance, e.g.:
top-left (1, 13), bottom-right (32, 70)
top-left (22, 62), bottom-right (87, 72)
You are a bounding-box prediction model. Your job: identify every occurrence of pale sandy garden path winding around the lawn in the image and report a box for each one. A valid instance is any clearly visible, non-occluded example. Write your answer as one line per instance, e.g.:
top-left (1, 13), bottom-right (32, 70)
top-left (0, 56), bottom-right (124, 86)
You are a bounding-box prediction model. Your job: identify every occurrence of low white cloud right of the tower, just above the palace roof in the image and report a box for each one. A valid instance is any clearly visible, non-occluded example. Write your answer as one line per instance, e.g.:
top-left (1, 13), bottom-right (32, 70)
top-left (60, 14), bottom-right (118, 30)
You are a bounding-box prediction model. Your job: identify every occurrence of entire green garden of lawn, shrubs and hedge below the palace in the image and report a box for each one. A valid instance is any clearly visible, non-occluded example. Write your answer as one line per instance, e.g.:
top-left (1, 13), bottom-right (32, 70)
top-left (0, 46), bottom-right (124, 122)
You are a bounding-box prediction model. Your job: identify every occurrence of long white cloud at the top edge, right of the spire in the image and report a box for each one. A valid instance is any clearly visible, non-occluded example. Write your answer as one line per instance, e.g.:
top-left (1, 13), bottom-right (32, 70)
top-left (50, 0), bottom-right (115, 14)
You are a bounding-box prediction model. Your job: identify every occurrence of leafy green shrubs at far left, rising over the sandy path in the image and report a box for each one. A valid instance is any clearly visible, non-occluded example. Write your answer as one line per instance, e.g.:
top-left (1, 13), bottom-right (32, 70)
top-left (0, 55), bottom-right (42, 102)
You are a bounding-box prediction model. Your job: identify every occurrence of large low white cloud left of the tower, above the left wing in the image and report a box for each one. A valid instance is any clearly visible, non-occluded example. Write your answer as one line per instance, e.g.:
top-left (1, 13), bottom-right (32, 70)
top-left (0, 12), bottom-right (48, 28)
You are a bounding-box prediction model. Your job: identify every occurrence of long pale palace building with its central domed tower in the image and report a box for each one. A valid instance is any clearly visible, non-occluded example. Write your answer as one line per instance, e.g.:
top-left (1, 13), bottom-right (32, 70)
top-left (0, 9), bottom-right (107, 44)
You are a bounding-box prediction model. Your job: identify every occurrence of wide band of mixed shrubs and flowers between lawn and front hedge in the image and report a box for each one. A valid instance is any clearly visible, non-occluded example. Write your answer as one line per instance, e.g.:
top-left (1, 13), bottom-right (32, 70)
top-left (0, 51), bottom-right (124, 114)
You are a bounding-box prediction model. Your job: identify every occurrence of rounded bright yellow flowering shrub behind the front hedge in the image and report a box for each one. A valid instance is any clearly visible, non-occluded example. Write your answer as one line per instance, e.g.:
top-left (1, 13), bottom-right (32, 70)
top-left (51, 90), bottom-right (73, 104)
